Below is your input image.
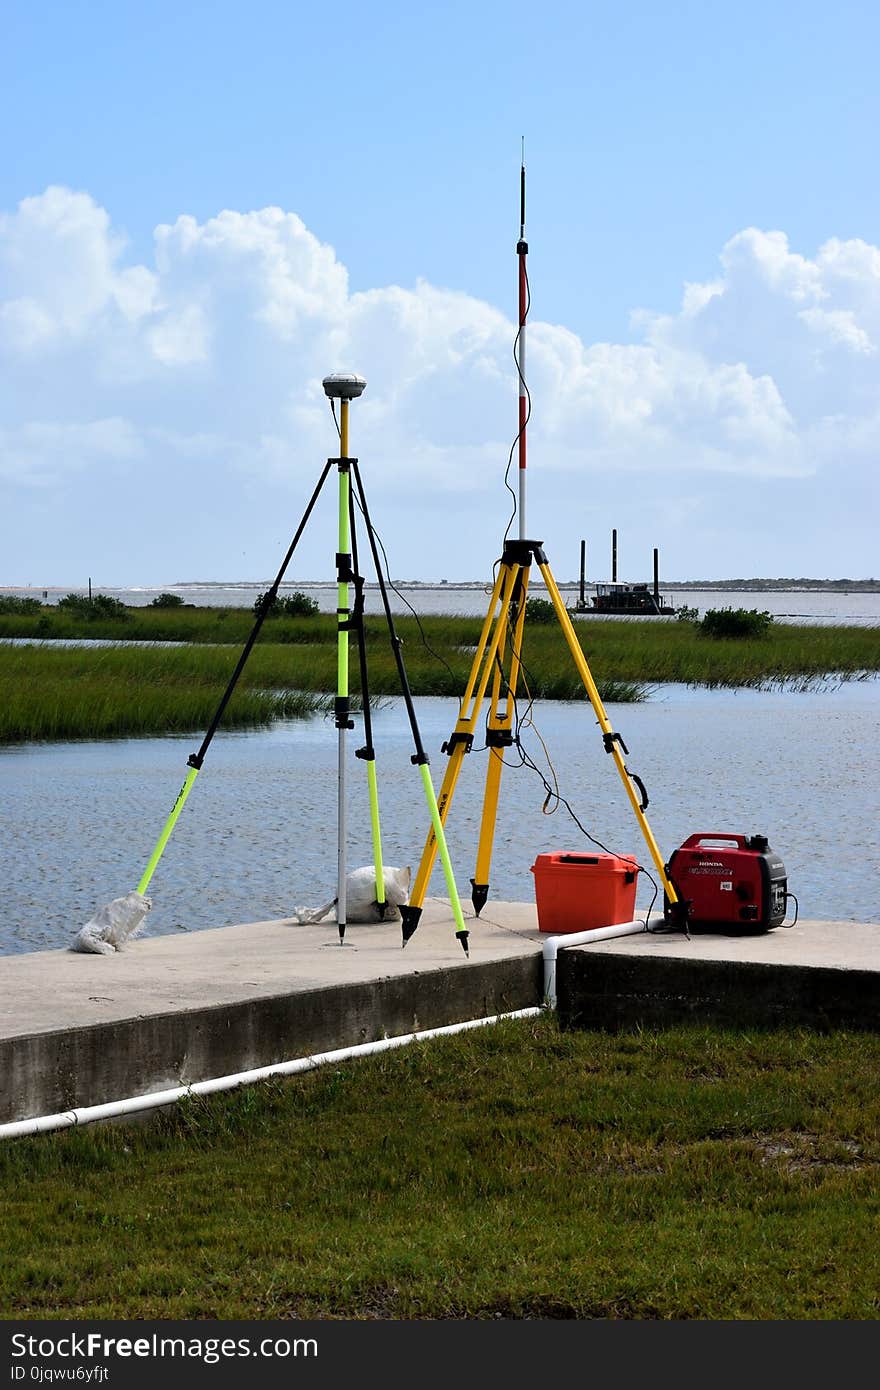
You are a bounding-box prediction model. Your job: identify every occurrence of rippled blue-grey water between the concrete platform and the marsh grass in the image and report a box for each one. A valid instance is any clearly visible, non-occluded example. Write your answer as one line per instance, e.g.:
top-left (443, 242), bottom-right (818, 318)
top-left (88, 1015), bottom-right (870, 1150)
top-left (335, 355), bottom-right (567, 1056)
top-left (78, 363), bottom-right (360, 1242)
top-left (0, 680), bottom-right (880, 969)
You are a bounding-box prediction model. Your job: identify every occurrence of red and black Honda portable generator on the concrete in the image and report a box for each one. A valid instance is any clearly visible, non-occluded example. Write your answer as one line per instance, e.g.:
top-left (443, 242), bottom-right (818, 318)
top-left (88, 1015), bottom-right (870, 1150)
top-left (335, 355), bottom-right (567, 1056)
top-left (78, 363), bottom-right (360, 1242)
top-left (663, 833), bottom-right (788, 931)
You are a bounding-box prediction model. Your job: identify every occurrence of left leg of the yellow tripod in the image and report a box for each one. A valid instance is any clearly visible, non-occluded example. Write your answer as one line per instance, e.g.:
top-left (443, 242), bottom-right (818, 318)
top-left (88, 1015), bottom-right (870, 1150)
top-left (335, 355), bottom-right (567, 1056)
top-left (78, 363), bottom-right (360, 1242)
top-left (410, 564), bottom-right (520, 910)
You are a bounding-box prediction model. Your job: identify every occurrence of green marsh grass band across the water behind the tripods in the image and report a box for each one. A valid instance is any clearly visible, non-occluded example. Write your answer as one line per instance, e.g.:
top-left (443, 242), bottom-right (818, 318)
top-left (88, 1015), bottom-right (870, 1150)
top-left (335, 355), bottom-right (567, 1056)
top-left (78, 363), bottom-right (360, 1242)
top-left (0, 609), bottom-right (880, 742)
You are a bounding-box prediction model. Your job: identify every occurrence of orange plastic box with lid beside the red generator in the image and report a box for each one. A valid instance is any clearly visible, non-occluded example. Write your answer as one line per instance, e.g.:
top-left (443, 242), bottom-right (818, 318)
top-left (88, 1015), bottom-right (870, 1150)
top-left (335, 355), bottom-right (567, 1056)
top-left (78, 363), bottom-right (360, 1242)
top-left (531, 853), bottom-right (638, 935)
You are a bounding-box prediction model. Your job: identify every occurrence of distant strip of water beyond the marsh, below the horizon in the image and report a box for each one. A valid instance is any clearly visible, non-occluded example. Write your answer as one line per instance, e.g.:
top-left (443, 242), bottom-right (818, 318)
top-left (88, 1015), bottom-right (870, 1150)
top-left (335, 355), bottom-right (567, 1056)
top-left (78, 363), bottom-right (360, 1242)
top-left (0, 580), bottom-right (880, 627)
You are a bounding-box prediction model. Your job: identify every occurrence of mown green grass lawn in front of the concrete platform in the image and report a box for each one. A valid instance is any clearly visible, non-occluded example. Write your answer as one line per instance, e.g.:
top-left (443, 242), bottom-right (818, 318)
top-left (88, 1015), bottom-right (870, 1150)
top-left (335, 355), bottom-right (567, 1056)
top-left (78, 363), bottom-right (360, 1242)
top-left (0, 1016), bottom-right (880, 1319)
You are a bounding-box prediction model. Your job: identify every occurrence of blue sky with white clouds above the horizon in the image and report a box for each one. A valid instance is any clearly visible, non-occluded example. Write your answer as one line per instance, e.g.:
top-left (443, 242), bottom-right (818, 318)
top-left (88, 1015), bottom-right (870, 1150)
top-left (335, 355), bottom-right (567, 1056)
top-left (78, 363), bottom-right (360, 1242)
top-left (0, 0), bottom-right (880, 587)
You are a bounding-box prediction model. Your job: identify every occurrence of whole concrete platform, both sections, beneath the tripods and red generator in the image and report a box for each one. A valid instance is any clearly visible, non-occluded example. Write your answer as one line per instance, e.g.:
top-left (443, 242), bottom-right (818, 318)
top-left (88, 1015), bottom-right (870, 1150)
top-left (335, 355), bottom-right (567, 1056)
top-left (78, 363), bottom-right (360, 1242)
top-left (0, 898), bottom-right (880, 1123)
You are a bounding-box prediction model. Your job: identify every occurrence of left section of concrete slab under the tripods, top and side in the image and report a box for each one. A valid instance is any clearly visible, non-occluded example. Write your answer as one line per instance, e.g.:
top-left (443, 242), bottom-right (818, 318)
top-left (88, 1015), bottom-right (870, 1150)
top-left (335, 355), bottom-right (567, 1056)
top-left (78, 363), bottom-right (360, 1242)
top-left (0, 899), bottom-right (544, 1123)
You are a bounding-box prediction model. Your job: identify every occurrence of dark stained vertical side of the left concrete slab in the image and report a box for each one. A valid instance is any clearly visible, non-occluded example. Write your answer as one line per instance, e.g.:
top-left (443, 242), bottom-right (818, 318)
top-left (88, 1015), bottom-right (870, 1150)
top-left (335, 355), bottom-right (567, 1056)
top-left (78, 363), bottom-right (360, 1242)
top-left (0, 955), bottom-right (544, 1123)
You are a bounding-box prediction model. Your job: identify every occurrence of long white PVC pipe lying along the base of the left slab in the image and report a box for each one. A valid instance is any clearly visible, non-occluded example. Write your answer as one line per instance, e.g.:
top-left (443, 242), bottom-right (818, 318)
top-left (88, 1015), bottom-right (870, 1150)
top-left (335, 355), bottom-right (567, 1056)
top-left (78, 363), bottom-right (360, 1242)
top-left (0, 1006), bottom-right (544, 1138)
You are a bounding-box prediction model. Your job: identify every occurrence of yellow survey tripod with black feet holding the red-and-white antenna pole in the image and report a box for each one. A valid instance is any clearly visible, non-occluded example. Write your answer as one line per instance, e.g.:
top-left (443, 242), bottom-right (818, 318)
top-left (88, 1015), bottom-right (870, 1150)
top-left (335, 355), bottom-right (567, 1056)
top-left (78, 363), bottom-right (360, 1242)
top-left (400, 539), bottom-right (678, 945)
